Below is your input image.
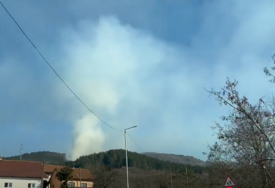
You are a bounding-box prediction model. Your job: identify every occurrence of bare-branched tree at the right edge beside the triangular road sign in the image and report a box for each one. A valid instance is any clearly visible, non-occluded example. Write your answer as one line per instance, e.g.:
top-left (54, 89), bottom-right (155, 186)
top-left (208, 79), bottom-right (275, 188)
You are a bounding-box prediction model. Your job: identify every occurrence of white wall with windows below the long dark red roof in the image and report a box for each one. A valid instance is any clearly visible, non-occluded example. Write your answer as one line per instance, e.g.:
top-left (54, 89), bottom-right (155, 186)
top-left (0, 177), bottom-right (43, 188)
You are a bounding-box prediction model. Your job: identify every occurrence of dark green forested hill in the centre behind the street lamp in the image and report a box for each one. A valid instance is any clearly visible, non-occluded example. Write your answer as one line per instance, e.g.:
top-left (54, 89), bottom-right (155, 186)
top-left (66, 149), bottom-right (204, 173)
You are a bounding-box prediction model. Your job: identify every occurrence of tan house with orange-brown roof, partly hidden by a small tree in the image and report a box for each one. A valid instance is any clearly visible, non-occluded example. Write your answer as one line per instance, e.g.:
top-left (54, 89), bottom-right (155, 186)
top-left (44, 165), bottom-right (93, 188)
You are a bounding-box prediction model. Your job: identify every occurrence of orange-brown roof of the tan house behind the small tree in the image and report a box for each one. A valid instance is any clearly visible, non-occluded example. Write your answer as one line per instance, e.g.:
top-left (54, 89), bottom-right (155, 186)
top-left (44, 164), bottom-right (93, 181)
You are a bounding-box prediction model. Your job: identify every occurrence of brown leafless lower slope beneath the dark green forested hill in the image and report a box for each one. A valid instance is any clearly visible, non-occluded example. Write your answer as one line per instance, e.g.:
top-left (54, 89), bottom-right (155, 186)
top-left (89, 167), bottom-right (207, 188)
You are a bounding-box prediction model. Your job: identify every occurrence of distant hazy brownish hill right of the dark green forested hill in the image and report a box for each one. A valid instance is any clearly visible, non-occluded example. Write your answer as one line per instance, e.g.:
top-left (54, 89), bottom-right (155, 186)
top-left (143, 152), bottom-right (206, 166)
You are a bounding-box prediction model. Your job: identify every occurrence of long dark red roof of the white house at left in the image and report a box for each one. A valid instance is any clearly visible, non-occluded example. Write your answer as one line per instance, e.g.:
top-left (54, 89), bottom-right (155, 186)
top-left (0, 160), bottom-right (46, 179)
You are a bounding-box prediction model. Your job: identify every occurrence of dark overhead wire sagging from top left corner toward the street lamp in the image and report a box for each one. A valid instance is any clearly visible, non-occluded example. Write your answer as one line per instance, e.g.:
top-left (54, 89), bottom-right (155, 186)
top-left (0, 1), bottom-right (121, 131)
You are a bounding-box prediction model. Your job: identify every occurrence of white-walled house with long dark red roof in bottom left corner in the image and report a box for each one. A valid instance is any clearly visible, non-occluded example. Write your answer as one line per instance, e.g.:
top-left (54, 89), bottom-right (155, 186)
top-left (0, 159), bottom-right (48, 188)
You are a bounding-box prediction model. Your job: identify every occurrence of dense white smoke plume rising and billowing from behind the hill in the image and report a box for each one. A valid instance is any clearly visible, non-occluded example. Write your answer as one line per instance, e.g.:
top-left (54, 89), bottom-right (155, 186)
top-left (56, 17), bottom-right (196, 159)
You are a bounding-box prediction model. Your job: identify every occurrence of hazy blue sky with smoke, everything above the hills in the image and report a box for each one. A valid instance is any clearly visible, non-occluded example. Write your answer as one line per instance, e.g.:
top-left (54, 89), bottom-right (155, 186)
top-left (0, 0), bottom-right (275, 160)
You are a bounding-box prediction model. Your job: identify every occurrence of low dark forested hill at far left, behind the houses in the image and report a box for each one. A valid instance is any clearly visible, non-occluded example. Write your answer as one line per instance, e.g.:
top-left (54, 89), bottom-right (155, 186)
top-left (4, 151), bottom-right (66, 164)
